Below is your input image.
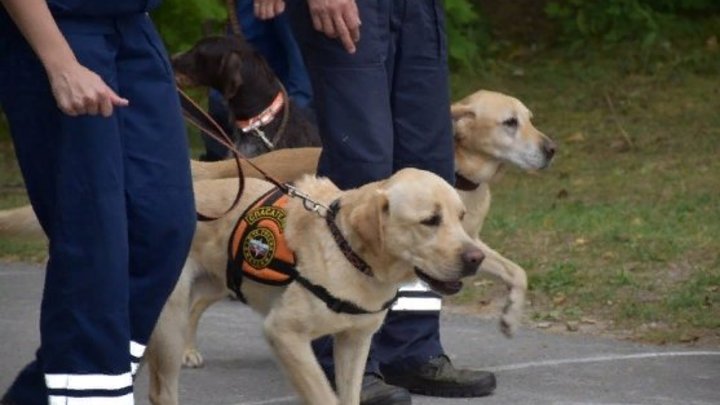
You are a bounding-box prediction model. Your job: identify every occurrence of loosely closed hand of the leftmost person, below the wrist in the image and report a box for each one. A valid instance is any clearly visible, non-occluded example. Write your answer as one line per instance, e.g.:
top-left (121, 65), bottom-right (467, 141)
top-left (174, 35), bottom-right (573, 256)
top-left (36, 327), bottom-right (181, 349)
top-left (47, 61), bottom-right (129, 117)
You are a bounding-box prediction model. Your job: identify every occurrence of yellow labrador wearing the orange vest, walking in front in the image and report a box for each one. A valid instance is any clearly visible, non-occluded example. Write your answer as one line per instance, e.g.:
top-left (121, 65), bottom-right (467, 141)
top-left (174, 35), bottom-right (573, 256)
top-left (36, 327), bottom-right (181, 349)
top-left (146, 169), bottom-right (484, 405)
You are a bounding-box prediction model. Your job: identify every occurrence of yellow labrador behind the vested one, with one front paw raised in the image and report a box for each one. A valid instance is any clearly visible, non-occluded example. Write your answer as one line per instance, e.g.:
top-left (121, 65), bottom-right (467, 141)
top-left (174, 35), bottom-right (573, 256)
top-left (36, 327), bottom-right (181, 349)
top-left (187, 90), bottom-right (557, 338)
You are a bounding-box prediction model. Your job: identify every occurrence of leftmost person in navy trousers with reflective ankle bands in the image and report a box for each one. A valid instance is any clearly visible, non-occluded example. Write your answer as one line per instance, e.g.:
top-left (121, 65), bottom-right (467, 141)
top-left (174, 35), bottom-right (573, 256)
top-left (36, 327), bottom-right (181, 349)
top-left (0, 0), bottom-right (195, 405)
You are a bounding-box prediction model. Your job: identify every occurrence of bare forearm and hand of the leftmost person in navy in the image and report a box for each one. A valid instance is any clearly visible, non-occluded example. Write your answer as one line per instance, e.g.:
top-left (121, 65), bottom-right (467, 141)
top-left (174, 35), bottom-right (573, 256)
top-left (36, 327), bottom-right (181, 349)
top-left (0, 0), bottom-right (128, 117)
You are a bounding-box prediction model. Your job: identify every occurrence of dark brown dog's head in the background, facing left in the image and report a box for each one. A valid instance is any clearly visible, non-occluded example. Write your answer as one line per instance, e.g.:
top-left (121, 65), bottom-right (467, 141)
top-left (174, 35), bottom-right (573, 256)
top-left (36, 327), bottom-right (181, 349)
top-left (172, 35), bottom-right (275, 100)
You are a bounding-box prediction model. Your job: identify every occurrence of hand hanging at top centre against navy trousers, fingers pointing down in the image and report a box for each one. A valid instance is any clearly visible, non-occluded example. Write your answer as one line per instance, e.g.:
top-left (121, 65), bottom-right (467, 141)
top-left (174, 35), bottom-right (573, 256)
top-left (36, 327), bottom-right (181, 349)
top-left (308, 0), bottom-right (360, 53)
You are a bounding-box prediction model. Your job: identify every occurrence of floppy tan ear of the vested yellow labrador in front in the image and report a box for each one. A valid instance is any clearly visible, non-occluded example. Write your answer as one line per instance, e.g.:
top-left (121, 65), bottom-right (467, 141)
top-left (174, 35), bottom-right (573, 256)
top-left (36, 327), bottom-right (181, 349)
top-left (350, 190), bottom-right (390, 253)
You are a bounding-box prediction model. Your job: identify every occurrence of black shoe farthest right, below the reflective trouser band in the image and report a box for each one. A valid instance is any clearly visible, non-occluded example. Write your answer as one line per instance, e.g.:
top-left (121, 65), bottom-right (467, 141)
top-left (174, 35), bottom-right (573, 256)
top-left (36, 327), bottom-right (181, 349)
top-left (383, 355), bottom-right (496, 398)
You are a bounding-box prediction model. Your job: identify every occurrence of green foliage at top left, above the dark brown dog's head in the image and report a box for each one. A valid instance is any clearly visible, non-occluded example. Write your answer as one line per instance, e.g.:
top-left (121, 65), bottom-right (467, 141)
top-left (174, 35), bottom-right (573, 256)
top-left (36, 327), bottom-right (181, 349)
top-left (152, 0), bottom-right (227, 53)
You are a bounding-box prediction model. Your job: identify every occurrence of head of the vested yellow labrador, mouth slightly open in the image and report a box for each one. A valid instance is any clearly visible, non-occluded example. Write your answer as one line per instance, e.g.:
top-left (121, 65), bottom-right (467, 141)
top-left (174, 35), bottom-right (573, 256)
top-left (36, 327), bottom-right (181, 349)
top-left (341, 169), bottom-right (485, 294)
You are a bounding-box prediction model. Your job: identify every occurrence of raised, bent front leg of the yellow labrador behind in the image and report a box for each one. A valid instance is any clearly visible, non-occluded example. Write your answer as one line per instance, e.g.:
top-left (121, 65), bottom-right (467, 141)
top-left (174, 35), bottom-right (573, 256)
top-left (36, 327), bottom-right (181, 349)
top-left (479, 241), bottom-right (527, 337)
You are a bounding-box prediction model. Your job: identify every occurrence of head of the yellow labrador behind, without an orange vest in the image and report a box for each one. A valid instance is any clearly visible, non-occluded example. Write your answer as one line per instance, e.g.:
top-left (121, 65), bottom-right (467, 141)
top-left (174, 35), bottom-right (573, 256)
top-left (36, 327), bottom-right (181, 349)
top-left (451, 90), bottom-right (557, 174)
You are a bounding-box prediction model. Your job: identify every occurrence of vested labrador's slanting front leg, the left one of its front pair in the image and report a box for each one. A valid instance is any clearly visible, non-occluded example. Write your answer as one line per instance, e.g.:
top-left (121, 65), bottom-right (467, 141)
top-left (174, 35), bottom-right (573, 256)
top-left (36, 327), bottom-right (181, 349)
top-left (264, 311), bottom-right (338, 405)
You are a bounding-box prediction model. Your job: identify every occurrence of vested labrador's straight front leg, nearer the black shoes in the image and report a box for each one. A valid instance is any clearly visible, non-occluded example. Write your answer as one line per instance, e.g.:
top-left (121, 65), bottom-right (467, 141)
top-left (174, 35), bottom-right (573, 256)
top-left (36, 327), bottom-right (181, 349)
top-left (333, 329), bottom-right (373, 405)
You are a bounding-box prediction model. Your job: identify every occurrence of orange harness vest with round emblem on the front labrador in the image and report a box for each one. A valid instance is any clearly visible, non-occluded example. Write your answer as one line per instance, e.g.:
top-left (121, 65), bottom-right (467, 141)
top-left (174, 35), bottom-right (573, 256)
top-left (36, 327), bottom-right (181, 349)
top-left (227, 188), bottom-right (297, 297)
